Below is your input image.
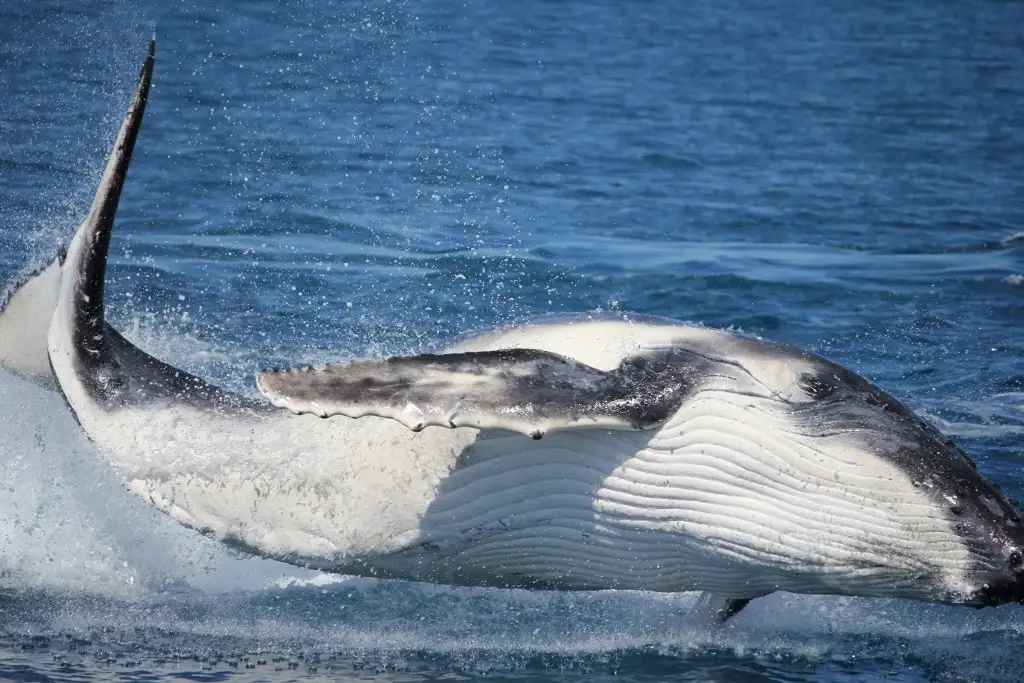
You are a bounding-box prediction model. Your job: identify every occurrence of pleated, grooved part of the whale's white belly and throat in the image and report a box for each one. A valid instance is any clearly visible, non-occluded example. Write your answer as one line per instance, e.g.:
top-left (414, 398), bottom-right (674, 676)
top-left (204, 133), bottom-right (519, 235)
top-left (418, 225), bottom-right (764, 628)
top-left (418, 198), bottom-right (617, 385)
top-left (382, 398), bottom-right (969, 596)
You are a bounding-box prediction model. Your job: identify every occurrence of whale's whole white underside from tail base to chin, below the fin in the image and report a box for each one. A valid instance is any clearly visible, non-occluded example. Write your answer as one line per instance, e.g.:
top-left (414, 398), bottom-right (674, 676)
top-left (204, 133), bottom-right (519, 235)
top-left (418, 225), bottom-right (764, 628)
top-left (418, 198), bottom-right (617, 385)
top-left (79, 382), bottom-right (972, 602)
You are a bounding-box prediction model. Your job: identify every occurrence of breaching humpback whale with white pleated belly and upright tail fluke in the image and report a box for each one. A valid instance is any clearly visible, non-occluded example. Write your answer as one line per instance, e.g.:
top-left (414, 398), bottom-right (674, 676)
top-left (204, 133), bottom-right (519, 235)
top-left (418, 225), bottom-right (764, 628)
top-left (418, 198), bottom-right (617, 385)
top-left (37, 45), bottom-right (1024, 615)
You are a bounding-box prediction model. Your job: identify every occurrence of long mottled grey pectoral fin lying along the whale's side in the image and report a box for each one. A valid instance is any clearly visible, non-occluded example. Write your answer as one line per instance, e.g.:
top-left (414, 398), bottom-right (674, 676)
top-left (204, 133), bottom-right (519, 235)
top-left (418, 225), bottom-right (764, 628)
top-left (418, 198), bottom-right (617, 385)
top-left (257, 349), bottom-right (689, 438)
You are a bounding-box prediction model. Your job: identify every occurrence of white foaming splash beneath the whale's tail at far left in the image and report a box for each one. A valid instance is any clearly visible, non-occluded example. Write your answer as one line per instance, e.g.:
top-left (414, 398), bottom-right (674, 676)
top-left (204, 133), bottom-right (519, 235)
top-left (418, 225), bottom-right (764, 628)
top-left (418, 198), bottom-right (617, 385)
top-left (0, 372), bottom-right (310, 599)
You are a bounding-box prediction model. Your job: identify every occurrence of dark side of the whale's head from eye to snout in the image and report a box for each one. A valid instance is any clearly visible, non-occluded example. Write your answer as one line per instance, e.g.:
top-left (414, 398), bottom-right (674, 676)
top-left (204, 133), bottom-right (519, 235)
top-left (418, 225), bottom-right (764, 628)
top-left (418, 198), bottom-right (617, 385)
top-left (774, 352), bottom-right (1024, 607)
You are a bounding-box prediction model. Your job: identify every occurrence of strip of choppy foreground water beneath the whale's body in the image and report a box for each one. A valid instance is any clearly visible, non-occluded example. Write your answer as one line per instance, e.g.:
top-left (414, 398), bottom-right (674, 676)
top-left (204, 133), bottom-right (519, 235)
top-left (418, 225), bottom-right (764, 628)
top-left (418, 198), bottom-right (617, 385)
top-left (0, 582), bottom-right (1022, 681)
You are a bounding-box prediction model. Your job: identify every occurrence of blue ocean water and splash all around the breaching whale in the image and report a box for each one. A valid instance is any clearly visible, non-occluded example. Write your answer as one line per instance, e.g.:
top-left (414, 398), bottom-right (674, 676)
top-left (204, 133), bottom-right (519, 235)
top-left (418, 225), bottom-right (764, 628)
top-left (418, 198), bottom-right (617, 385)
top-left (0, 0), bottom-right (1024, 682)
